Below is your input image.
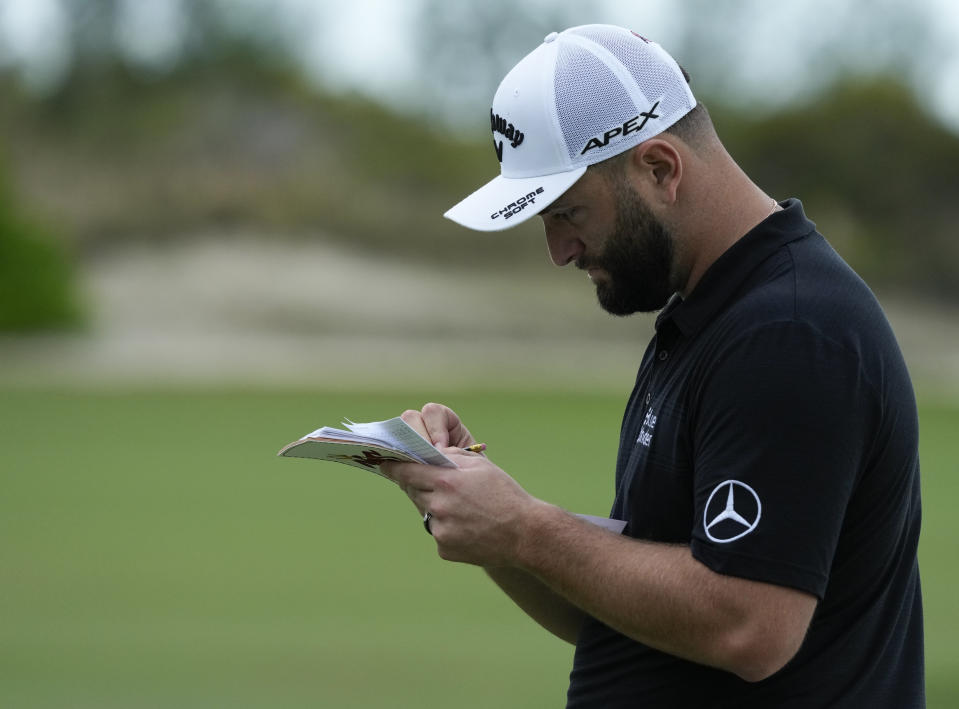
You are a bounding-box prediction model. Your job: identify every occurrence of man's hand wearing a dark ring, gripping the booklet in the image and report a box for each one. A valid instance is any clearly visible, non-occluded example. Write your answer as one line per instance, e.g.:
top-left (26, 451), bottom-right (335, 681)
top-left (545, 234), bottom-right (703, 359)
top-left (382, 448), bottom-right (541, 567)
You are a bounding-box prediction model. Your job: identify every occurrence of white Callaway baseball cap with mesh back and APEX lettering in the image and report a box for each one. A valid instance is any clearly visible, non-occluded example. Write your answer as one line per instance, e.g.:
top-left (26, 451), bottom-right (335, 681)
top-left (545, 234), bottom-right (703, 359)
top-left (443, 25), bottom-right (696, 231)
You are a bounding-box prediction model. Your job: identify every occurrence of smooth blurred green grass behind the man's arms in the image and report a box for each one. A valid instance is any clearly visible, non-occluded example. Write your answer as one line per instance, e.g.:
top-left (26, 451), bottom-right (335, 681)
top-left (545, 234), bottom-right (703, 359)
top-left (0, 392), bottom-right (959, 709)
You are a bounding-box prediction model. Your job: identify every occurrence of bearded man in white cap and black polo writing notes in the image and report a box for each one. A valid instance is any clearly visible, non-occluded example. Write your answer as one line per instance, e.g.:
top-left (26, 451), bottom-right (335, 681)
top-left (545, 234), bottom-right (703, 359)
top-left (387, 25), bottom-right (924, 709)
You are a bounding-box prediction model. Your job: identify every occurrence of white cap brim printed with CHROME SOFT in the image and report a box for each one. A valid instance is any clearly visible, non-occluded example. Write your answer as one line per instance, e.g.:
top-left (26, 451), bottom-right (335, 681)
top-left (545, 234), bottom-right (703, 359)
top-left (443, 166), bottom-right (586, 231)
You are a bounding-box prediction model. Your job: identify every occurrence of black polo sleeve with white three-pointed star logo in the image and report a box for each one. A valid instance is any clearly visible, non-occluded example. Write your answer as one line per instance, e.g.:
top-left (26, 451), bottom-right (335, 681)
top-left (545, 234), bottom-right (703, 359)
top-left (691, 321), bottom-right (874, 598)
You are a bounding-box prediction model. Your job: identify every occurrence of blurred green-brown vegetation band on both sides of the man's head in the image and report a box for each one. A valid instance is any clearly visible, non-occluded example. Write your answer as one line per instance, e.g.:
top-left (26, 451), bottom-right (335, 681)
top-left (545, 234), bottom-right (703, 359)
top-left (0, 53), bottom-right (959, 301)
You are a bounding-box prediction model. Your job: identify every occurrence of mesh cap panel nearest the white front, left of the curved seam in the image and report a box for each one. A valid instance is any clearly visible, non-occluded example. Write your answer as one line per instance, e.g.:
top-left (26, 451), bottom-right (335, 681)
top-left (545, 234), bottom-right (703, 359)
top-left (553, 42), bottom-right (636, 165)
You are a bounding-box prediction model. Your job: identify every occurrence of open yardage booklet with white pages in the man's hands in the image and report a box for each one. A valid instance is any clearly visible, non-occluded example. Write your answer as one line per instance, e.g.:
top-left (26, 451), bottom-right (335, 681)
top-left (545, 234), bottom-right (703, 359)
top-left (277, 416), bottom-right (456, 477)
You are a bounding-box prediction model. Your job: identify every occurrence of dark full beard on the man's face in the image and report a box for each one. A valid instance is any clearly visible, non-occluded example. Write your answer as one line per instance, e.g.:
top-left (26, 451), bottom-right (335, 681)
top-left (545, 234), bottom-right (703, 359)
top-left (577, 183), bottom-right (678, 315)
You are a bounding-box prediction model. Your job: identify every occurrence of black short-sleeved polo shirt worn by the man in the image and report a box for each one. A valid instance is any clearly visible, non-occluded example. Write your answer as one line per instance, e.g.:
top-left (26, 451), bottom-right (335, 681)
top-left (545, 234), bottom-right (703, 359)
top-left (568, 200), bottom-right (925, 709)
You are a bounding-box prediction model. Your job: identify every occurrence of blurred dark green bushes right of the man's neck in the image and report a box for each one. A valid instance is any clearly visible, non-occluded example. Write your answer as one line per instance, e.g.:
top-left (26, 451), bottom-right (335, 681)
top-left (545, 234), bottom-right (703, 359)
top-left (713, 77), bottom-right (959, 299)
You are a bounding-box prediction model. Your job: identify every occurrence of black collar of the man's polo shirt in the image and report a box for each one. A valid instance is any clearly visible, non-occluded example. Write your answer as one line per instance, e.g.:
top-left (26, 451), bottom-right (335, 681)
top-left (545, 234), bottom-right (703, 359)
top-left (656, 198), bottom-right (816, 337)
